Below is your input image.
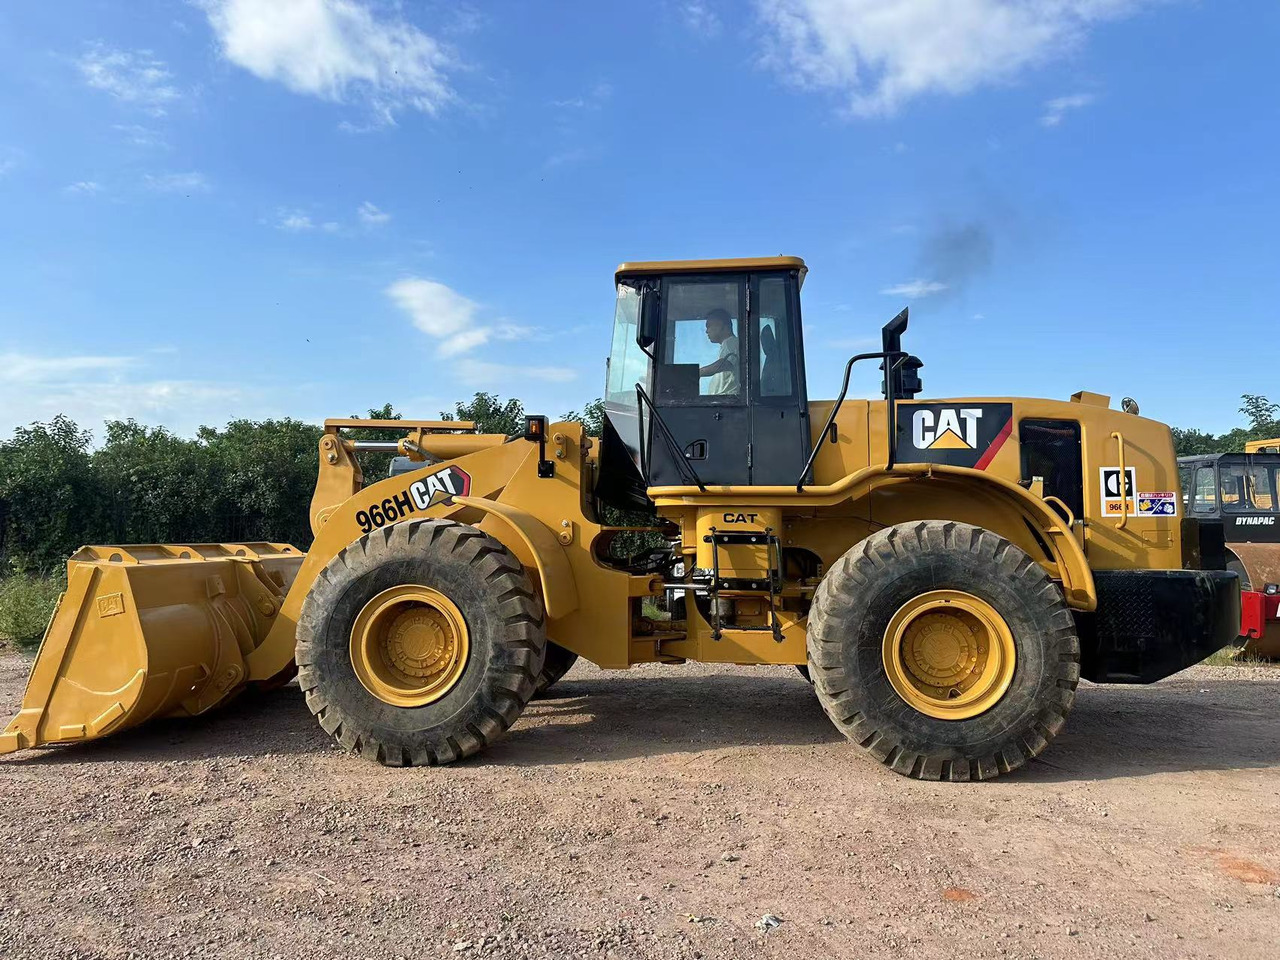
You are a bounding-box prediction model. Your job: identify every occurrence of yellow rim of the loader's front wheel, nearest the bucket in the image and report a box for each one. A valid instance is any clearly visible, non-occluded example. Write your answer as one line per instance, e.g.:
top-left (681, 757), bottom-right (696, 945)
top-left (351, 584), bottom-right (471, 707)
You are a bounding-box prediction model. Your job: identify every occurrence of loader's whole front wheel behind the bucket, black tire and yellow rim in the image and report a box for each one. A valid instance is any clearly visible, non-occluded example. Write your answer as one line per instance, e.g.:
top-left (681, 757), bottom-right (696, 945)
top-left (296, 520), bottom-right (547, 767)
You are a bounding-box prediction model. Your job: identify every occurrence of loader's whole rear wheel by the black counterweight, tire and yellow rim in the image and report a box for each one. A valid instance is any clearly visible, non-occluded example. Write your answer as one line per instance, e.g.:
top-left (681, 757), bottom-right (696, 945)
top-left (808, 521), bottom-right (1080, 781)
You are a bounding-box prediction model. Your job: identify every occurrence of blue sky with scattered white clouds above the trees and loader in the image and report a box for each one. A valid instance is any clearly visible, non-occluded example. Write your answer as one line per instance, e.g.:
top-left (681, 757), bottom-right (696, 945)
top-left (0, 0), bottom-right (1280, 434)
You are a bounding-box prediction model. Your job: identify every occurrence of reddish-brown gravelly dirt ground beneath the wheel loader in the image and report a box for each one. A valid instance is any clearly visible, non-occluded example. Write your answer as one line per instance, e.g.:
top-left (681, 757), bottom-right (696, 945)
top-left (0, 653), bottom-right (1280, 960)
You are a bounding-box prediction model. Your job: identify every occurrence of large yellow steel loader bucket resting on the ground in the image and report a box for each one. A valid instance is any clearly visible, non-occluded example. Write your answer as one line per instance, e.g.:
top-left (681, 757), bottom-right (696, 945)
top-left (0, 543), bottom-right (303, 754)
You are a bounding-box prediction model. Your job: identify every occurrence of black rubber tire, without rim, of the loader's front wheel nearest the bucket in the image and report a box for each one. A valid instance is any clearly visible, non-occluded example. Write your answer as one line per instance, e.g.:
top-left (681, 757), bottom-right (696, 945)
top-left (296, 520), bottom-right (547, 767)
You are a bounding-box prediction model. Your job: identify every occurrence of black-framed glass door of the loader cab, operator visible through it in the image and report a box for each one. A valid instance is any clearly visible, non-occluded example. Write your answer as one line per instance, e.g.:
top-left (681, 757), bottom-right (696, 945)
top-left (648, 274), bottom-right (751, 486)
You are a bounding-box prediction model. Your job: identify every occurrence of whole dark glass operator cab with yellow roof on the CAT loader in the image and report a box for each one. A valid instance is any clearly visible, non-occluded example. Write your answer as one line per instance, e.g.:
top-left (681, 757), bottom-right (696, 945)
top-left (596, 257), bottom-right (809, 503)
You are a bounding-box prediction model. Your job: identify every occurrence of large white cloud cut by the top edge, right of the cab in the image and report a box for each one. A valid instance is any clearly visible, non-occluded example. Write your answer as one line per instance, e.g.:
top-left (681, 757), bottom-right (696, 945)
top-left (756, 0), bottom-right (1151, 116)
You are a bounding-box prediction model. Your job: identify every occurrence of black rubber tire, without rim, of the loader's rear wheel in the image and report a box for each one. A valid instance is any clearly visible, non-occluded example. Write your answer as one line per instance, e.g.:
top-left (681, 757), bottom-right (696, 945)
top-left (808, 521), bottom-right (1080, 781)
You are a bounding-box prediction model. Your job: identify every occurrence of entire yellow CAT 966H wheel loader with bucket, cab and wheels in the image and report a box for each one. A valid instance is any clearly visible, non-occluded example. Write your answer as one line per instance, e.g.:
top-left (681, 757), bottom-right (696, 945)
top-left (0, 257), bottom-right (1240, 780)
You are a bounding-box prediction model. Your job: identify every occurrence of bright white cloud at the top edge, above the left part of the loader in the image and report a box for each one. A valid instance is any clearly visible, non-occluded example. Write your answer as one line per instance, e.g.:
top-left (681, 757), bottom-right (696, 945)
top-left (198, 0), bottom-right (453, 129)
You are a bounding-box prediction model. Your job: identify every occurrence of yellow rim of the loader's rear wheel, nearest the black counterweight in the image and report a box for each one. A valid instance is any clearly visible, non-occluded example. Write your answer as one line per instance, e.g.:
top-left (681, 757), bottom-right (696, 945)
top-left (882, 590), bottom-right (1018, 719)
